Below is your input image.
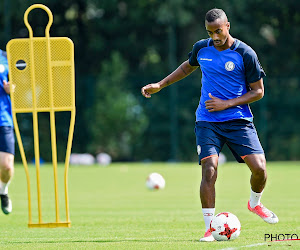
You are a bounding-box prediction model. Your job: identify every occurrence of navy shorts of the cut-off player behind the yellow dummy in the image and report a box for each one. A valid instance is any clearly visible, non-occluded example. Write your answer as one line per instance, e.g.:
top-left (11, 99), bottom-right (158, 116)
top-left (0, 126), bottom-right (15, 155)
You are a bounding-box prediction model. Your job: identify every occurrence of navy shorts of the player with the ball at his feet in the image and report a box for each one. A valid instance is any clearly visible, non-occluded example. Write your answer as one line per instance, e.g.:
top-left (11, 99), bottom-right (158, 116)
top-left (195, 119), bottom-right (264, 164)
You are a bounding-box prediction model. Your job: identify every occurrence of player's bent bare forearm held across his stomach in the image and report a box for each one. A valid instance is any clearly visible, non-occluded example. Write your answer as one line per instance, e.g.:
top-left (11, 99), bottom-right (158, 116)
top-left (205, 78), bottom-right (264, 112)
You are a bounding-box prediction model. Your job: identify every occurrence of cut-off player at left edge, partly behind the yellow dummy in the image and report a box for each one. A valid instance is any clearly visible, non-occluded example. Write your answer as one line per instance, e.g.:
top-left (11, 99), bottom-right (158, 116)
top-left (0, 50), bottom-right (15, 214)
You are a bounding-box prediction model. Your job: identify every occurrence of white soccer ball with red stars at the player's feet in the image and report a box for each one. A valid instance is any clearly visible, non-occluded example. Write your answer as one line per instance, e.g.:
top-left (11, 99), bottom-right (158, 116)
top-left (210, 212), bottom-right (241, 241)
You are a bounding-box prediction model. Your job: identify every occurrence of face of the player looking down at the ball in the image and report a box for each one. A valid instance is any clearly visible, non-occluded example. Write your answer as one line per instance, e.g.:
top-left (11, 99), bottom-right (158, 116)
top-left (205, 19), bottom-right (230, 47)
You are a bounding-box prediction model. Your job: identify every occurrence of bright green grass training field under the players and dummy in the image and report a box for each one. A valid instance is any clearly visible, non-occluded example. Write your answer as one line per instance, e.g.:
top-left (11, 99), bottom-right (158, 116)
top-left (0, 162), bottom-right (300, 249)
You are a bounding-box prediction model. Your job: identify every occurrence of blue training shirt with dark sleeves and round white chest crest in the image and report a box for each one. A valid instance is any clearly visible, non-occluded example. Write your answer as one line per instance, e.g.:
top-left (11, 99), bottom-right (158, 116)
top-left (189, 38), bottom-right (266, 122)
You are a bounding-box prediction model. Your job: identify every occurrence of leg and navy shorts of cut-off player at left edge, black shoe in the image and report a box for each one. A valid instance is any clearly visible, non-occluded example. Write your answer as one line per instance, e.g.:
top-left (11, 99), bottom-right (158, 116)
top-left (0, 127), bottom-right (15, 214)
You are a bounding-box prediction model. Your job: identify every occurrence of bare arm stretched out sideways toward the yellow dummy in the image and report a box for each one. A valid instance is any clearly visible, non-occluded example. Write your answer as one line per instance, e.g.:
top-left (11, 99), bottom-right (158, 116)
top-left (141, 60), bottom-right (198, 98)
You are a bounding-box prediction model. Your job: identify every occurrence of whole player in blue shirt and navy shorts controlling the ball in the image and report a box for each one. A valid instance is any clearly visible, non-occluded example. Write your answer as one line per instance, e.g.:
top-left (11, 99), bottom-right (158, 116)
top-left (142, 9), bottom-right (278, 241)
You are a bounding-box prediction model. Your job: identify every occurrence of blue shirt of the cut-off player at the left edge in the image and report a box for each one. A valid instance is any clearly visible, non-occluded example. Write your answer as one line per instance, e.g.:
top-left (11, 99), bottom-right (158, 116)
top-left (0, 49), bottom-right (13, 127)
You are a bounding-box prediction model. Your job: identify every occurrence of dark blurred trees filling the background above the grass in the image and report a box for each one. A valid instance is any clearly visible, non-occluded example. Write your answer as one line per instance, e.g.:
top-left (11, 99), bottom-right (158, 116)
top-left (0, 0), bottom-right (300, 160)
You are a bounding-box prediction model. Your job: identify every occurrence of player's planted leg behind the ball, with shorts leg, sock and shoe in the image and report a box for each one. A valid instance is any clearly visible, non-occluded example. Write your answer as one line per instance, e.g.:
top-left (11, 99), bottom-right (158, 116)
top-left (195, 122), bottom-right (225, 241)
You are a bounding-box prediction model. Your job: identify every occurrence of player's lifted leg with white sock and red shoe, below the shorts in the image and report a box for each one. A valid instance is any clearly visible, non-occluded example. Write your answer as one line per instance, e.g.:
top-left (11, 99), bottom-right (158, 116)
top-left (244, 154), bottom-right (278, 224)
